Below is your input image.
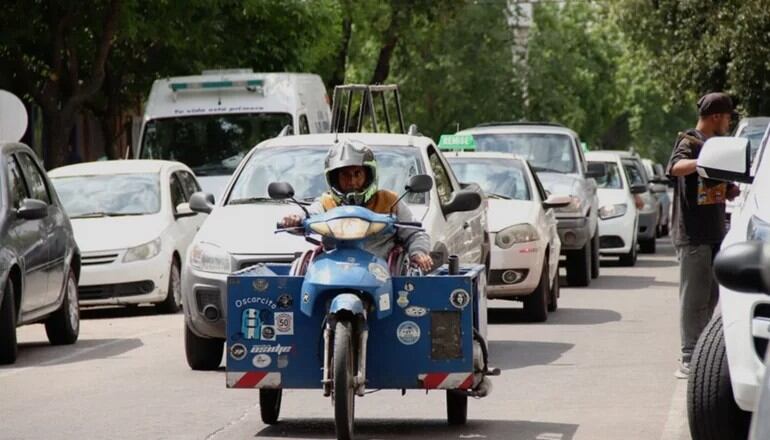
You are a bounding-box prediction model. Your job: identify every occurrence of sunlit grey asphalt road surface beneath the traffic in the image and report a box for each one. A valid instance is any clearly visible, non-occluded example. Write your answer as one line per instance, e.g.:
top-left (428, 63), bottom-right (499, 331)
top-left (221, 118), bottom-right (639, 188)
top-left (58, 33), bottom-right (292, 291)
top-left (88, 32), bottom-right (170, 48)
top-left (0, 240), bottom-right (689, 440)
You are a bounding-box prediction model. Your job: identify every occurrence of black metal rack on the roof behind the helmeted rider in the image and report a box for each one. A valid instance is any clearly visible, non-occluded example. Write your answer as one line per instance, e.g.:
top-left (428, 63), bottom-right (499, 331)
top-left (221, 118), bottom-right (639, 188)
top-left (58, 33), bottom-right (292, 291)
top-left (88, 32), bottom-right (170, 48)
top-left (332, 84), bottom-right (406, 134)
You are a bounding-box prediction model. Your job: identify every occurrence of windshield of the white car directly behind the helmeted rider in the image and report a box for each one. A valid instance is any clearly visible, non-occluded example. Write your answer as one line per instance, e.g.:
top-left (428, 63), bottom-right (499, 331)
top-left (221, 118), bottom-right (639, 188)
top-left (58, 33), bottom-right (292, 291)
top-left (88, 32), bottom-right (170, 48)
top-left (227, 146), bottom-right (426, 204)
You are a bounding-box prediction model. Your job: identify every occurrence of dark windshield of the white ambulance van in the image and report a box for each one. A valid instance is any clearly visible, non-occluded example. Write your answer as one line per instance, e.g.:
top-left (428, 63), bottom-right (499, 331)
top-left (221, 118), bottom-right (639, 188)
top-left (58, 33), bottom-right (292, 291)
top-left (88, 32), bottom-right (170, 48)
top-left (141, 113), bottom-right (292, 176)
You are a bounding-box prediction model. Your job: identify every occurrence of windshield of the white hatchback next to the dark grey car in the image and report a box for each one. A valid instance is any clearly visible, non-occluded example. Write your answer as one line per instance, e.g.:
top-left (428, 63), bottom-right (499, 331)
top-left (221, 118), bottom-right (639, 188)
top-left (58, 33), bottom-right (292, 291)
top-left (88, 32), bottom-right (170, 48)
top-left (51, 173), bottom-right (160, 218)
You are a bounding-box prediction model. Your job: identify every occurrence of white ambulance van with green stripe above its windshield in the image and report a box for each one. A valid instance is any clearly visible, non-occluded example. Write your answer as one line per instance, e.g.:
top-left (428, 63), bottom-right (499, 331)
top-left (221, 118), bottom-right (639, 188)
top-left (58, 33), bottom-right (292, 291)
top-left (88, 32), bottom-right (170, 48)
top-left (136, 69), bottom-right (331, 198)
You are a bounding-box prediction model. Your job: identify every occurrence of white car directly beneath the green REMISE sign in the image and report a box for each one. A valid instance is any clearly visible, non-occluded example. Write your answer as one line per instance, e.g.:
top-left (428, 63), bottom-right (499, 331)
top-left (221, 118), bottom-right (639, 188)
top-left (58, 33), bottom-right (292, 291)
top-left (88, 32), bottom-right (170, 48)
top-left (444, 152), bottom-right (570, 322)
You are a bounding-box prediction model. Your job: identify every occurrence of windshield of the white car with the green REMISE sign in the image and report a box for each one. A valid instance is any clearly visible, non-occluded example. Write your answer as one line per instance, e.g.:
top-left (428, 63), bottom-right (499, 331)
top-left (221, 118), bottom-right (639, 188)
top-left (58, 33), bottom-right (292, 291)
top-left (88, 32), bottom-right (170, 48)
top-left (448, 157), bottom-right (532, 200)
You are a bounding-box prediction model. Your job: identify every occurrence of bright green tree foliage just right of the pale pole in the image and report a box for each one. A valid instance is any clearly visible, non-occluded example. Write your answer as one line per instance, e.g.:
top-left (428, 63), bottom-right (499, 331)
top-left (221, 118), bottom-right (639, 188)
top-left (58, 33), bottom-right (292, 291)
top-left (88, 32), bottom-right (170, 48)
top-left (526, 1), bottom-right (622, 146)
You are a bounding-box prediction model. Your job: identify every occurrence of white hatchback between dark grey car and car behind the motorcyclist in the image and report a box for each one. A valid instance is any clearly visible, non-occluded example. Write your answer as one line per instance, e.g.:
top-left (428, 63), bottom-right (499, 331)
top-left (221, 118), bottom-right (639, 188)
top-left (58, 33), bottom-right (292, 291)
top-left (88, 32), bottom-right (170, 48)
top-left (48, 160), bottom-right (205, 313)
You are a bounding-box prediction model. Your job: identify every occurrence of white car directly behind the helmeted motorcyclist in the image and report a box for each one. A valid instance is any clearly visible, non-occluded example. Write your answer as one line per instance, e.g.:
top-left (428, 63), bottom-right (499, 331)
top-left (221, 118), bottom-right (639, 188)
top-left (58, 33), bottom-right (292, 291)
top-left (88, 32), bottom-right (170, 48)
top-left (182, 133), bottom-right (489, 370)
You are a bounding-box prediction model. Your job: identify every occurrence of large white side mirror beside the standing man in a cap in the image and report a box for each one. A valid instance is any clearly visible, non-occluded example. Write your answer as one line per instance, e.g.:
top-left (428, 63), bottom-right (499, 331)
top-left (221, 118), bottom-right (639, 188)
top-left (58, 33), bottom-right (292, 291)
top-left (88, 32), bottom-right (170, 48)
top-left (697, 136), bottom-right (754, 183)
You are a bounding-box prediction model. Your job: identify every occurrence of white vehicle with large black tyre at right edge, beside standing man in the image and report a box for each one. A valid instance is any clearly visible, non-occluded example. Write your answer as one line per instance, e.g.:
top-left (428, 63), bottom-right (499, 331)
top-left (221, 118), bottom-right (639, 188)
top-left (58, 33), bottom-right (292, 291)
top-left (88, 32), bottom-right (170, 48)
top-left (688, 136), bottom-right (770, 438)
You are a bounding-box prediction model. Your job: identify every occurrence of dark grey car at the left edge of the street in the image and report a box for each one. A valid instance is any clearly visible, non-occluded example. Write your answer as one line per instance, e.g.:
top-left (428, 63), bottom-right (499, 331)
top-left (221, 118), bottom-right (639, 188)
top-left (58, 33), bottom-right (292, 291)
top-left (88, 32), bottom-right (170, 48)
top-left (0, 143), bottom-right (80, 364)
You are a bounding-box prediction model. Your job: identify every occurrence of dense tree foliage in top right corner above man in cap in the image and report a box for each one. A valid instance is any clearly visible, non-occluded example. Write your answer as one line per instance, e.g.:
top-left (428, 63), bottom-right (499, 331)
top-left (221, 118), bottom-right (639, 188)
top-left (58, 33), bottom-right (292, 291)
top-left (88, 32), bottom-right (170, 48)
top-left (615, 0), bottom-right (770, 115)
